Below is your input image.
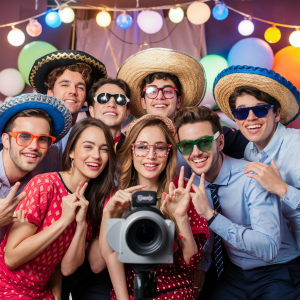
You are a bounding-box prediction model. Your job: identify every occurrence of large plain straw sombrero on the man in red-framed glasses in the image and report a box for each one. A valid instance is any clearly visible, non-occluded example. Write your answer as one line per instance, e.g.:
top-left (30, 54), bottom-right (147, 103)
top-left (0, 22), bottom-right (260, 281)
top-left (117, 48), bottom-right (206, 118)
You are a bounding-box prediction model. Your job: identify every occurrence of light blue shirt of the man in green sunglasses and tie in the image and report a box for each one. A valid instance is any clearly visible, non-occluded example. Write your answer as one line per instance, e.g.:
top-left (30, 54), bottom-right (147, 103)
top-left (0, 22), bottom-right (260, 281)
top-left (194, 154), bottom-right (300, 271)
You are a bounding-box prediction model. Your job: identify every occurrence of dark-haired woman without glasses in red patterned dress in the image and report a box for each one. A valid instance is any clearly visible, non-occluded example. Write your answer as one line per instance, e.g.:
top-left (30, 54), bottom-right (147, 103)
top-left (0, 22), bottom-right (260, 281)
top-left (0, 118), bottom-right (115, 300)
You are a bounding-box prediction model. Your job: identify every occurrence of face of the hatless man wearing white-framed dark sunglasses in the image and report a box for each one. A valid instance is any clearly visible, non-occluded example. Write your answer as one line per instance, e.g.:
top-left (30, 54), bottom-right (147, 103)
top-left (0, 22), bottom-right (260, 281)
top-left (89, 83), bottom-right (130, 131)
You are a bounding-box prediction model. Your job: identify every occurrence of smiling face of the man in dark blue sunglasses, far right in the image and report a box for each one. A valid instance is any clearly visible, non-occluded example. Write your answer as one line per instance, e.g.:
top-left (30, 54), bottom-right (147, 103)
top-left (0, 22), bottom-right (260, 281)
top-left (235, 94), bottom-right (280, 151)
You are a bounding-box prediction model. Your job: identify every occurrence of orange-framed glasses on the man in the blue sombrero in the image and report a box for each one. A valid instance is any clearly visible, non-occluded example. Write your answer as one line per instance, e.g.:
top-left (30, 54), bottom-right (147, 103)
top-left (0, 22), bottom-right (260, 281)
top-left (7, 131), bottom-right (56, 149)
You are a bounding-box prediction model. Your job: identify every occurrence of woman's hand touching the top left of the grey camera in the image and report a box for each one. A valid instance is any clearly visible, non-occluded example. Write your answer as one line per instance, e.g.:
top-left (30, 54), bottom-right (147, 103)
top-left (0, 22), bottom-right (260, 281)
top-left (103, 185), bottom-right (147, 214)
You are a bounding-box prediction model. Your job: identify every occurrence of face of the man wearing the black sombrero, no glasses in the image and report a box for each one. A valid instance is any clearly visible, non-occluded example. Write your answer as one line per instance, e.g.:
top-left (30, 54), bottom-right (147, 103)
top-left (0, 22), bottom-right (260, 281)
top-left (47, 70), bottom-right (86, 115)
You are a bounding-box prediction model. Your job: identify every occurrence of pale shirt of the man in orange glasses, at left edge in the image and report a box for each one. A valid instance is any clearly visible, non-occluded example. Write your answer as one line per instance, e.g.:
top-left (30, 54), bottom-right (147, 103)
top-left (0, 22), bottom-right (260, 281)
top-left (0, 150), bottom-right (33, 242)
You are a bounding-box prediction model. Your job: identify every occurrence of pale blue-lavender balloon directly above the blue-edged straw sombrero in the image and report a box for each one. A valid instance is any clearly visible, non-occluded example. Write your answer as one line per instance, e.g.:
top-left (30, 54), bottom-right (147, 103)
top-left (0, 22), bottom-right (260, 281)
top-left (228, 38), bottom-right (274, 69)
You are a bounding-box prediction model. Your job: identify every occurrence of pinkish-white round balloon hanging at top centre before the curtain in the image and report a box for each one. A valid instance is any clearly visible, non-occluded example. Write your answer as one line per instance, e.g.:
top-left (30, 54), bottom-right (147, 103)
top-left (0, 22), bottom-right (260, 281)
top-left (137, 10), bottom-right (163, 34)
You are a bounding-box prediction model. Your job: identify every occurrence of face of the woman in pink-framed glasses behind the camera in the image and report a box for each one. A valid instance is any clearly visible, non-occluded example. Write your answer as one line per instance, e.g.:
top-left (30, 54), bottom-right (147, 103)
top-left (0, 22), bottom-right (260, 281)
top-left (133, 126), bottom-right (168, 185)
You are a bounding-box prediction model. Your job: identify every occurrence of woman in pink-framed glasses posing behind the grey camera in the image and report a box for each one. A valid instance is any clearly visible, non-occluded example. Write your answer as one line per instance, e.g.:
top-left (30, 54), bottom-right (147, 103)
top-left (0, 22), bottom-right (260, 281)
top-left (100, 114), bottom-right (208, 300)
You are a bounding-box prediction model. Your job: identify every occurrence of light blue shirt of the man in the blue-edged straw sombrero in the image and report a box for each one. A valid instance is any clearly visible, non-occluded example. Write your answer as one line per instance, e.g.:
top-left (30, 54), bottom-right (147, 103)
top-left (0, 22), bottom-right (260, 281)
top-left (244, 123), bottom-right (300, 247)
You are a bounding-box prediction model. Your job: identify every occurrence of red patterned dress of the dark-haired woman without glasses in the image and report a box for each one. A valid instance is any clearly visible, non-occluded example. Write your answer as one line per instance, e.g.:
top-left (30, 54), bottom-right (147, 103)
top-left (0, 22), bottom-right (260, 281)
top-left (0, 173), bottom-right (92, 300)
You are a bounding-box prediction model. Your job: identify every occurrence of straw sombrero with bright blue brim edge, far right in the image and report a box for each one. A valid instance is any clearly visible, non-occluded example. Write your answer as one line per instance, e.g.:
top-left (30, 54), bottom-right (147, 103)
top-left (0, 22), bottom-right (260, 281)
top-left (213, 66), bottom-right (300, 125)
